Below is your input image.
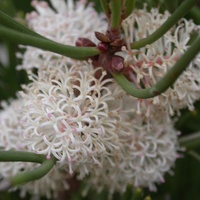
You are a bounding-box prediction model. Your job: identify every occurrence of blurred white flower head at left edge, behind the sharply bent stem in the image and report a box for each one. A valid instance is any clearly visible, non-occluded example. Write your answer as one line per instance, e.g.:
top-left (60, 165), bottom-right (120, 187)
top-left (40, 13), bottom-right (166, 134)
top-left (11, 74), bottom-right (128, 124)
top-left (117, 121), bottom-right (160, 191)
top-left (0, 98), bottom-right (69, 199)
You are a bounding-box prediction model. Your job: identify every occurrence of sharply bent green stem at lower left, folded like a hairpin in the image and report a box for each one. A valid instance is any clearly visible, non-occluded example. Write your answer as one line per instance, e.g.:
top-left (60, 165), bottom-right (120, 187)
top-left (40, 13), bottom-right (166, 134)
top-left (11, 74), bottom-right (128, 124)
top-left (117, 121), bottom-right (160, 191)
top-left (0, 151), bottom-right (56, 191)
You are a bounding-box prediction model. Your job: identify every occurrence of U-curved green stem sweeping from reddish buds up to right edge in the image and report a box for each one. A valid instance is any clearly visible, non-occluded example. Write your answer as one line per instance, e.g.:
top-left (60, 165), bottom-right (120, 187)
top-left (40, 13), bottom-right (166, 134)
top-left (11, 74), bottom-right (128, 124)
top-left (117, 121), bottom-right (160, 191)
top-left (112, 36), bottom-right (200, 99)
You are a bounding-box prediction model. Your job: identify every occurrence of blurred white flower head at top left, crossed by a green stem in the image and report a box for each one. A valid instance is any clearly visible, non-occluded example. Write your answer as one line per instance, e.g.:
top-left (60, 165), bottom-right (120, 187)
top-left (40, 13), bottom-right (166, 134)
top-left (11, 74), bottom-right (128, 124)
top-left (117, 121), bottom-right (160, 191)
top-left (18, 0), bottom-right (107, 70)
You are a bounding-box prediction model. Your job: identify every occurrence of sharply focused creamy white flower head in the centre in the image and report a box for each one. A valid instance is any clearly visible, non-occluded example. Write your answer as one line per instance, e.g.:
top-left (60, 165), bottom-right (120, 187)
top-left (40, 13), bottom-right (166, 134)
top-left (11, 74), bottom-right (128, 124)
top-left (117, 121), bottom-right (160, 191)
top-left (21, 60), bottom-right (121, 174)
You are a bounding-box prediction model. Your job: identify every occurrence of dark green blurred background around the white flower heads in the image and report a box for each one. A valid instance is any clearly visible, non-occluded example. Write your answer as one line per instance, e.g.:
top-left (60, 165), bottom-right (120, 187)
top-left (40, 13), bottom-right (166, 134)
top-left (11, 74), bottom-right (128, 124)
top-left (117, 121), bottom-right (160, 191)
top-left (0, 0), bottom-right (200, 200)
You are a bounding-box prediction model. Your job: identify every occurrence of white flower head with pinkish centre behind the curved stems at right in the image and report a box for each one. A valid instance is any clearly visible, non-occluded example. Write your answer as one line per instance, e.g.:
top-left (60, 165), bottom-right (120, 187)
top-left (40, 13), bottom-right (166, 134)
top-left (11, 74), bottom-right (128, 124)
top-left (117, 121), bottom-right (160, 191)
top-left (122, 8), bottom-right (200, 115)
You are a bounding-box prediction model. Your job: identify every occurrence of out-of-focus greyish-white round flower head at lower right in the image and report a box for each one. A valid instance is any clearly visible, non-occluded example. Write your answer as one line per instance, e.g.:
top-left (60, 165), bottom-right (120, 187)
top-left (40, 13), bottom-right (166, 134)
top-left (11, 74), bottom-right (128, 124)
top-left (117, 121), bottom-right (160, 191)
top-left (120, 116), bottom-right (178, 191)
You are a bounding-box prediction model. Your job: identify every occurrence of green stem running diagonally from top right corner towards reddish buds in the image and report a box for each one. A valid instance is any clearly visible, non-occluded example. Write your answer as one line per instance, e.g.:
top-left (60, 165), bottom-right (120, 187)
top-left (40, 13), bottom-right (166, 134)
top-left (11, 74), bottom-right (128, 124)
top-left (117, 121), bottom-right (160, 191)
top-left (131, 0), bottom-right (197, 49)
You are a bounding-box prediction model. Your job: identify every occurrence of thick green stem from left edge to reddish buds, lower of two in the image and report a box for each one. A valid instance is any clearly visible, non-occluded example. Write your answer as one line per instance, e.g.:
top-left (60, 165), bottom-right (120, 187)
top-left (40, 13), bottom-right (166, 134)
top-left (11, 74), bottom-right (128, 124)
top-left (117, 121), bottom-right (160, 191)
top-left (0, 26), bottom-right (100, 59)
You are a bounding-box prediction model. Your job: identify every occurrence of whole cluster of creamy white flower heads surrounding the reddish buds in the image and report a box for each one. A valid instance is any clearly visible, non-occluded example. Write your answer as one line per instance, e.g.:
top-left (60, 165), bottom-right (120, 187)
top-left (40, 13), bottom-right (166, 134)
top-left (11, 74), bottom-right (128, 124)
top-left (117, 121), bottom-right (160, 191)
top-left (0, 0), bottom-right (200, 198)
